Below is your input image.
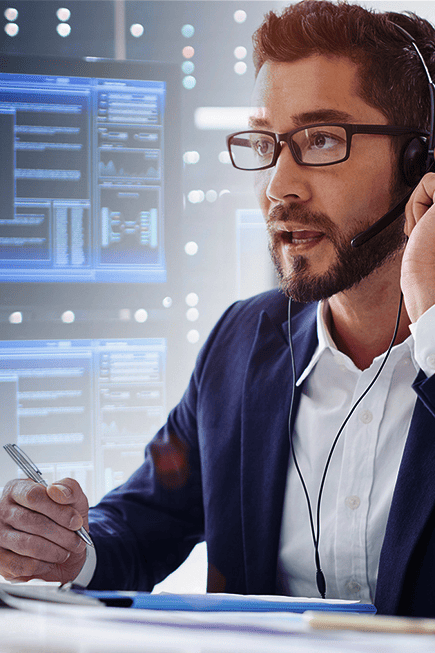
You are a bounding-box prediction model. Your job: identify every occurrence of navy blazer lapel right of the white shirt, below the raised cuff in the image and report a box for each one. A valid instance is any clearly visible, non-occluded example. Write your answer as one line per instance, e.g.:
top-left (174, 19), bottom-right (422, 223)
top-left (375, 377), bottom-right (435, 614)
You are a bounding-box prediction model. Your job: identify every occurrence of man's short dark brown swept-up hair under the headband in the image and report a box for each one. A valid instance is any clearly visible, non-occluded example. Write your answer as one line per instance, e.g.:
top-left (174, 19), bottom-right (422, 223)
top-left (253, 0), bottom-right (435, 129)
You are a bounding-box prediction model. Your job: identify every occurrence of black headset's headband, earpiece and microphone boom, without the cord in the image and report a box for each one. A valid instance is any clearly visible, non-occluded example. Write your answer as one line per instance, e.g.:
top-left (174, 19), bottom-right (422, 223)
top-left (351, 23), bottom-right (435, 247)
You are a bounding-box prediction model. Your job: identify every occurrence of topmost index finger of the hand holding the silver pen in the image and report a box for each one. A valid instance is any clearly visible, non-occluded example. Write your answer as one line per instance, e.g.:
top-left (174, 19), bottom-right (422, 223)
top-left (4, 481), bottom-right (83, 530)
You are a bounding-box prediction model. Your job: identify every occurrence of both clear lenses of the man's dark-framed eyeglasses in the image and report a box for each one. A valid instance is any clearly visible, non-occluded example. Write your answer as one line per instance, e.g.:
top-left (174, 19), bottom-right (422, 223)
top-left (230, 125), bottom-right (347, 170)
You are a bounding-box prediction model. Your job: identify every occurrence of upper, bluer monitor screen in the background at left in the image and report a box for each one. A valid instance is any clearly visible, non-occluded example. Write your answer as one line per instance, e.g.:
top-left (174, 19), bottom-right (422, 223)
top-left (0, 55), bottom-right (176, 283)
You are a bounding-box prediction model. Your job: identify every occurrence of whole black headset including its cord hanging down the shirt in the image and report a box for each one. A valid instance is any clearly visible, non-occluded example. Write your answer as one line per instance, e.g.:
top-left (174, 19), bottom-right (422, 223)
top-left (288, 23), bottom-right (435, 598)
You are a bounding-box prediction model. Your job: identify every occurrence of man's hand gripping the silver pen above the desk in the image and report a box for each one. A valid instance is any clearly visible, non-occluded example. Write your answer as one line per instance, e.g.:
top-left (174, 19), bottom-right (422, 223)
top-left (0, 478), bottom-right (88, 583)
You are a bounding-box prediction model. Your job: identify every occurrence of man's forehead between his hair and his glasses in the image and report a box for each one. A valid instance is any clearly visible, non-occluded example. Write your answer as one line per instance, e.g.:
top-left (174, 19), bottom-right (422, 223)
top-left (252, 55), bottom-right (386, 133)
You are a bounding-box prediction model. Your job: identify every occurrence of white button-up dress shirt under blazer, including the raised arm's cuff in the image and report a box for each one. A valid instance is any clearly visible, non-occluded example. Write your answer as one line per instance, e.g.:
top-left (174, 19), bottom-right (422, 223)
top-left (278, 303), bottom-right (435, 602)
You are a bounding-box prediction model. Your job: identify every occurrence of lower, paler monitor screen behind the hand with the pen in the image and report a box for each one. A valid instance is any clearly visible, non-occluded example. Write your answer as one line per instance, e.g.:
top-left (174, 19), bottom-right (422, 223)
top-left (0, 338), bottom-right (167, 504)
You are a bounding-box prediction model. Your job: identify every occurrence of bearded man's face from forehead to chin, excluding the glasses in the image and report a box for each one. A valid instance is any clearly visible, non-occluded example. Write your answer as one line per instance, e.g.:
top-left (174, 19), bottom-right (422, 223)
top-left (251, 56), bottom-right (404, 302)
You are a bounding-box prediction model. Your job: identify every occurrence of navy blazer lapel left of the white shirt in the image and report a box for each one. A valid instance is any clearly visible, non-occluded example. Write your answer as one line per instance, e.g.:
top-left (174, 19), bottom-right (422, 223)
top-left (241, 307), bottom-right (315, 594)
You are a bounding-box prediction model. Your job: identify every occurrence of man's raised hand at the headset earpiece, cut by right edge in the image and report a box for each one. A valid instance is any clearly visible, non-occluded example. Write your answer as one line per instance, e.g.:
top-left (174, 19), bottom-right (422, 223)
top-left (401, 172), bottom-right (435, 322)
